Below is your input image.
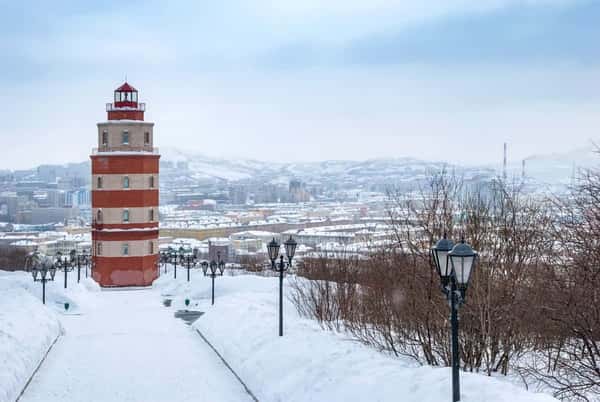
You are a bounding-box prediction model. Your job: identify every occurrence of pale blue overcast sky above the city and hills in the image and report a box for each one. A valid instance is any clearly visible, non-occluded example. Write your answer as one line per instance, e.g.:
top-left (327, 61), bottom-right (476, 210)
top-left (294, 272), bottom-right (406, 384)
top-left (0, 0), bottom-right (600, 168)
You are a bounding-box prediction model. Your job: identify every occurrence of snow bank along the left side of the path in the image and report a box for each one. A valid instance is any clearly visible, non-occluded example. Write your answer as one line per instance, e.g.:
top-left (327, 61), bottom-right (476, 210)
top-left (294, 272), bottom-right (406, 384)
top-left (0, 271), bottom-right (98, 402)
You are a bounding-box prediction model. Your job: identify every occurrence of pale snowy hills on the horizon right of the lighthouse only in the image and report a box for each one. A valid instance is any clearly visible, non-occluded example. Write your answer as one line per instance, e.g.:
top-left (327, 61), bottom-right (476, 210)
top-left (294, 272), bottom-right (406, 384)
top-left (156, 143), bottom-right (600, 186)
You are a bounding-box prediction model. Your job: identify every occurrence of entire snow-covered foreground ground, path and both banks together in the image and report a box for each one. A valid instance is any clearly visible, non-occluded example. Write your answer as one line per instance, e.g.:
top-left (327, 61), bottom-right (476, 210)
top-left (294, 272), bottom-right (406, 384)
top-left (0, 270), bottom-right (555, 402)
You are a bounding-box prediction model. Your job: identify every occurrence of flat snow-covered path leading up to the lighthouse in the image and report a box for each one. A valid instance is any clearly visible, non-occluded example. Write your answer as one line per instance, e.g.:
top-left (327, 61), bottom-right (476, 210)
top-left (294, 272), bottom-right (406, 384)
top-left (20, 289), bottom-right (251, 402)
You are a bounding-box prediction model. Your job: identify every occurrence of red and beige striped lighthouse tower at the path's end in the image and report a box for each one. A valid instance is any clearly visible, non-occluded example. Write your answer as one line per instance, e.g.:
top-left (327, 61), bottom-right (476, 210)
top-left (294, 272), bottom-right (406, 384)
top-left (90, 82), bottom-right (160, 287)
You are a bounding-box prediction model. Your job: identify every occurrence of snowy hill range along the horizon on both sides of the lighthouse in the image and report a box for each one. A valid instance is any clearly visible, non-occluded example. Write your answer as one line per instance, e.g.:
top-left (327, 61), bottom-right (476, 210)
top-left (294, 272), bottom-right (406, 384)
top-left (19, 141), bottom-right (600, 190)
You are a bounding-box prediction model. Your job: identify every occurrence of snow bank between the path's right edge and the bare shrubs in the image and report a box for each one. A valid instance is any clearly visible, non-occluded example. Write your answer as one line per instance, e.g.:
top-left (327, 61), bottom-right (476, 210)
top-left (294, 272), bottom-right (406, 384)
top-left (155, 271), bottom-right (556, 402)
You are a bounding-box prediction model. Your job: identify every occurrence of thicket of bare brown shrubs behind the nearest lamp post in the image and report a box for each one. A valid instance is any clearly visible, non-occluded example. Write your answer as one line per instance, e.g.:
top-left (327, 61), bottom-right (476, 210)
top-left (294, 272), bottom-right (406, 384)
top-left (292, 166), bottom-right (600, 400)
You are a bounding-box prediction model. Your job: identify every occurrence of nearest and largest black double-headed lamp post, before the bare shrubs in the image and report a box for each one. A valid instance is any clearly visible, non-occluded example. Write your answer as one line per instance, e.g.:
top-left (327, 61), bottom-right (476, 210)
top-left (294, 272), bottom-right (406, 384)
top-left (431, 233), bottom-right (478, 402)
